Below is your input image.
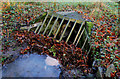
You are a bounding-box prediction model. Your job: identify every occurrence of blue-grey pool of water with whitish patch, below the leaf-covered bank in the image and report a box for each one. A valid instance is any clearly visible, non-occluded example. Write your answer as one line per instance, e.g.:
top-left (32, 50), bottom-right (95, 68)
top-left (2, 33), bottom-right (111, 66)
top-left (2, 54), bottom-right (61, 77)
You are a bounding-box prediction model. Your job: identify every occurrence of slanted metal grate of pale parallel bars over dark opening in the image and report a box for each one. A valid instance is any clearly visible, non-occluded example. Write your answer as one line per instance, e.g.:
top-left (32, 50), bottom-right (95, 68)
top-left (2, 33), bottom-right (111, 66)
top-left (29, 12), bottom-right (91, 52)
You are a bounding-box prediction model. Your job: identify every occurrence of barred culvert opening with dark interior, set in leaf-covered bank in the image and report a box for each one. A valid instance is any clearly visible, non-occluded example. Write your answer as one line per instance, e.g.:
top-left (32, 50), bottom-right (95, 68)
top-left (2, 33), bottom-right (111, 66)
top-left (1, 12), bottom-right (94, 78)
